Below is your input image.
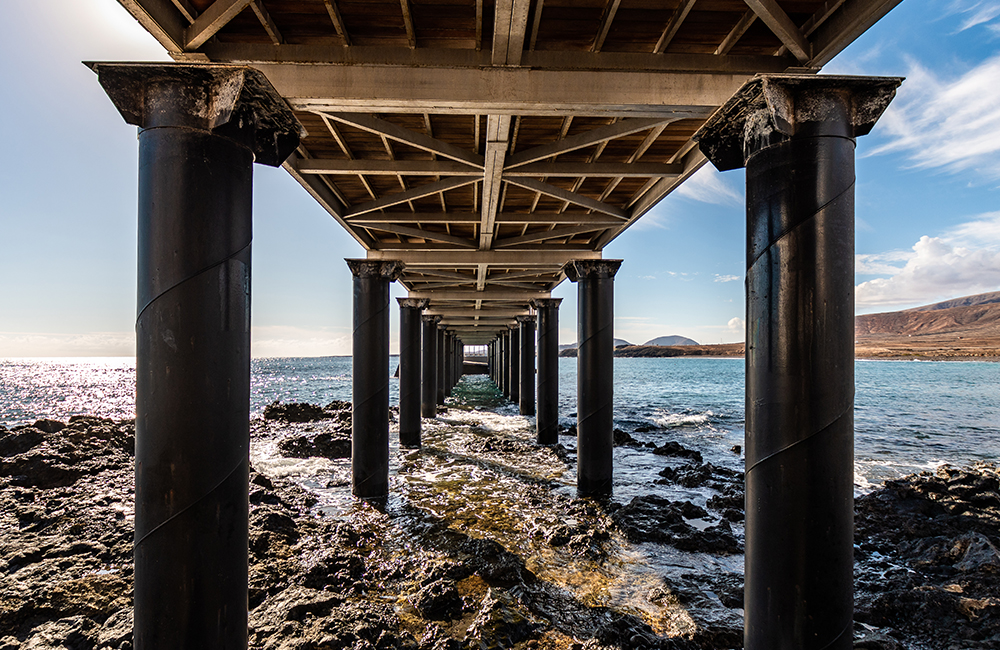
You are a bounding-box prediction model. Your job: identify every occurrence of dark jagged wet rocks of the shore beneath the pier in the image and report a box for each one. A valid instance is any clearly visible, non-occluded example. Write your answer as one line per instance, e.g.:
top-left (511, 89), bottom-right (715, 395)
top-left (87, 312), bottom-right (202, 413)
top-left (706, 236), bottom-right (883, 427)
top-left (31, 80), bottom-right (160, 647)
top-left (0, 402), bottom-right (1000, 650)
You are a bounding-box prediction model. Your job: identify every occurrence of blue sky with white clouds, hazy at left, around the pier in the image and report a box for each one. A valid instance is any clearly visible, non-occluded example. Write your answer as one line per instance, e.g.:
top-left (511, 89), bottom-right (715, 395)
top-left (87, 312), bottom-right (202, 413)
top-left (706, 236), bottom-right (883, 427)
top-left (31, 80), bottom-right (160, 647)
top-left (0, 0), bottom-right (1000, 357)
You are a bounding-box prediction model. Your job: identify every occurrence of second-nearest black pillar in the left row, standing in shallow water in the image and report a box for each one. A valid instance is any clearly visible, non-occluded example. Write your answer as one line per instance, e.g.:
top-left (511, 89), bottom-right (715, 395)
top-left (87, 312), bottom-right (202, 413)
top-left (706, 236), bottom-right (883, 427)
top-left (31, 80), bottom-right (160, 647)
top-left (345, 260), bottom-right (403, 499)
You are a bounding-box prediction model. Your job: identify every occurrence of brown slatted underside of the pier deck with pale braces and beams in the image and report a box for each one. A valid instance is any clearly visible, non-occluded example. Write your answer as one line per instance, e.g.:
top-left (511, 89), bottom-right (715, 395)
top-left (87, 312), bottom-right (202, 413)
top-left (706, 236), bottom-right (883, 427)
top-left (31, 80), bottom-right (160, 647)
top-left (120, 0), bottom-right (899, 344)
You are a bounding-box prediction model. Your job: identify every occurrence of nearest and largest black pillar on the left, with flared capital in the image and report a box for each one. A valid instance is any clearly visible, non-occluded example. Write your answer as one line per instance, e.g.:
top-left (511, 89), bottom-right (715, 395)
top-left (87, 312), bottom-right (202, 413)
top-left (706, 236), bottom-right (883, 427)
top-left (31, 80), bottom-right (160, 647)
top-left (91, 63), bottom-right (302, 650)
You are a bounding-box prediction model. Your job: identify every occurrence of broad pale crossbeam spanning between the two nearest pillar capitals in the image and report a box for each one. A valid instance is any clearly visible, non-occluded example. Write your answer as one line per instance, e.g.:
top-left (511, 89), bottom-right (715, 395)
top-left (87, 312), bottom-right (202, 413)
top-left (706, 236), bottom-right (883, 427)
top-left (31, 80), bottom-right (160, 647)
top-left (255, 66), bottom-right (749, 117)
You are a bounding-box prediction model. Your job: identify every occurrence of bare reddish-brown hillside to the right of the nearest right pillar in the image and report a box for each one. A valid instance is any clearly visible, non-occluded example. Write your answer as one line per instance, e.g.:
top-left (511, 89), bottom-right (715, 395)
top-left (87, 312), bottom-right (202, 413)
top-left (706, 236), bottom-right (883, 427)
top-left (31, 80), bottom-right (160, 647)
top-left (854, 291), bottom-right (1000, 339)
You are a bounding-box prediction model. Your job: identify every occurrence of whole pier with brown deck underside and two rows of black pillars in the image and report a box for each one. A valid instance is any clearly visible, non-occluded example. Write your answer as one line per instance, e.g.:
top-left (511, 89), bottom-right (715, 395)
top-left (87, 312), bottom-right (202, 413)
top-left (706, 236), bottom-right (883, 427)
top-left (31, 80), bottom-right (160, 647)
top-left (89, 0), bottom-right (900, 650)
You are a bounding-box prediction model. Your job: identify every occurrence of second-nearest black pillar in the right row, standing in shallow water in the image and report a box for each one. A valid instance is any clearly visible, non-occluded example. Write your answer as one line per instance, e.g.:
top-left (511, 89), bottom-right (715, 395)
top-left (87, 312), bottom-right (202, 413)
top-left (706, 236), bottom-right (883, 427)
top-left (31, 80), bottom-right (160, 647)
top-left (563, 260), bottom-right (622, 494)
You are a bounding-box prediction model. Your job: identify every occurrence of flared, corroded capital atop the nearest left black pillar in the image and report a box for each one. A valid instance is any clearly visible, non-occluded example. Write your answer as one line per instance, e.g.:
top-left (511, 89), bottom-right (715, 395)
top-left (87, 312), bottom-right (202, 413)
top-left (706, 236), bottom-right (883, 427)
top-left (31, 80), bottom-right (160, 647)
top-left (86, 63), bottom-right (306, 167)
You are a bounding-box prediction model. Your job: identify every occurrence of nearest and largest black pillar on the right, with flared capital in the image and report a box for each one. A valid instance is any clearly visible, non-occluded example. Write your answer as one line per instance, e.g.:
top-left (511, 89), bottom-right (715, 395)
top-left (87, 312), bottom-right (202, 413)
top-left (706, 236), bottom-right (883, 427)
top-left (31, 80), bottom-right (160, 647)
top-left (700, 75), bottom-right (900, 650)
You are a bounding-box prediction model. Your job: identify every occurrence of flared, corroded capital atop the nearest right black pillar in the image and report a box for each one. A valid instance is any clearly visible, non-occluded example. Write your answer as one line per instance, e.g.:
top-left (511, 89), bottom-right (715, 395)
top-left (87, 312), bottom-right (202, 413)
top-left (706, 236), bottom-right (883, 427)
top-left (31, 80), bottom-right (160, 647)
top-left (694, 75), bottom-right (903, 171)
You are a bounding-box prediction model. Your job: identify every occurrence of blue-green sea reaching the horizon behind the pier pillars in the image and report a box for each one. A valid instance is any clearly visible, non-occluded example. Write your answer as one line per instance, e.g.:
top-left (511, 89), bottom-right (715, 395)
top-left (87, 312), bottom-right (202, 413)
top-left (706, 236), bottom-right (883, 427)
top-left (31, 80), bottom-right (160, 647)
top-left (0, 356), bottom-right (1000, 486)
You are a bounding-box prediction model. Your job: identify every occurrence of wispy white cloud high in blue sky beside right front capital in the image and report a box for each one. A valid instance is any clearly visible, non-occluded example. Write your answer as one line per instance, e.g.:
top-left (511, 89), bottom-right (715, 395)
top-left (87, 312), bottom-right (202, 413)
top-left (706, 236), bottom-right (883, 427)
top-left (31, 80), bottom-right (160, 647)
top-left (873, 55), bottom-right (1000, 180)
